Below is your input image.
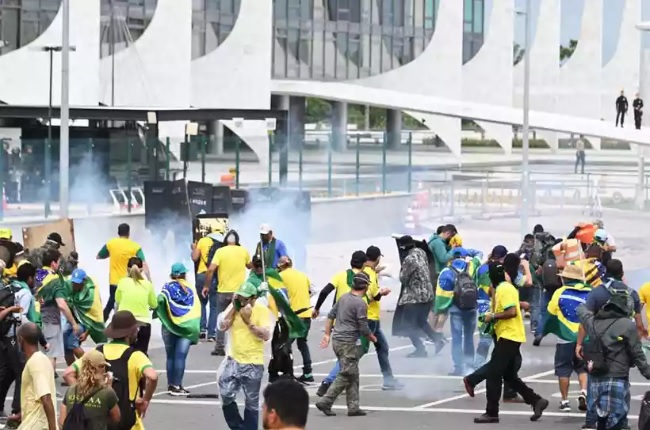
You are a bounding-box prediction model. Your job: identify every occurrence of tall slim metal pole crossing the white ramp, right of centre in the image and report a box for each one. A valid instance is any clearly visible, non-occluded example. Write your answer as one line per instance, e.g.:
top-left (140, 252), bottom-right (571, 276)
top-left (521, 0), bottom-right (532, 237)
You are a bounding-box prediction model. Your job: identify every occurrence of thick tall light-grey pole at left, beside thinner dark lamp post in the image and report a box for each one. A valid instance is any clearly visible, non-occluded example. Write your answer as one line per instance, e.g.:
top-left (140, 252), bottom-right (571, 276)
top-left (59, 0), bottom-right (70, 218)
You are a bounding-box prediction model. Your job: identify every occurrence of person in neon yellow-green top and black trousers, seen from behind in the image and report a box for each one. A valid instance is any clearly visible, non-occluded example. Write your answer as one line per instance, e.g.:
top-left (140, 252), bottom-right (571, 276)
top-left (115, 257), bottom-right (158, 355)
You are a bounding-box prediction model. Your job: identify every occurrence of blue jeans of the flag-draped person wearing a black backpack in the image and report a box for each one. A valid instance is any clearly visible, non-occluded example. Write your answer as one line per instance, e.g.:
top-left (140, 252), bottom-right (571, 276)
top-left (449, 305), bottom-right (478, 373)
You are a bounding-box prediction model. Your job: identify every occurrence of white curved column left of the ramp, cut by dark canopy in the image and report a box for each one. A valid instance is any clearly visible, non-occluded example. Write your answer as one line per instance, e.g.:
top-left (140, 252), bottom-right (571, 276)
top-left (190, 0), bottom-right (273, 167)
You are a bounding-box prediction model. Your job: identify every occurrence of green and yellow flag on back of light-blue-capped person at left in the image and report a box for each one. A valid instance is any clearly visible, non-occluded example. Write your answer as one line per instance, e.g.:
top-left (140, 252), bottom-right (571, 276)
top-left (66, 277), bottom-right (107, 343)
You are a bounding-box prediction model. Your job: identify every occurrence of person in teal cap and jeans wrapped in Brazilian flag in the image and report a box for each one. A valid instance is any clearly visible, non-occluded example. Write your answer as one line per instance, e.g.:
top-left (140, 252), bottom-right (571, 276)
top-left (156, 263), bottom-right (201, 396)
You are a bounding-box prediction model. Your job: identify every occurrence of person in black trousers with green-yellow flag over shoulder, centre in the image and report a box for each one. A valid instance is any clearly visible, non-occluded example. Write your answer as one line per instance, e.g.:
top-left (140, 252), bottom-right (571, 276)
top-left (246, 255), bottom-right (307, 383)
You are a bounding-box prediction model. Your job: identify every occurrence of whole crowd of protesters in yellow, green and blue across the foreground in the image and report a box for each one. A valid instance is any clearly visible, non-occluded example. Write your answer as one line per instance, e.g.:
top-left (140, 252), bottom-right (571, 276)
top-left (0, 220), bottom-right (650, 430)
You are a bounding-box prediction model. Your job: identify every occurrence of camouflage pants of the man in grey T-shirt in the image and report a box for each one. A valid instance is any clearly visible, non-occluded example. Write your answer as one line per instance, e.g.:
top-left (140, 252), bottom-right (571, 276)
top-left (322, 340), bottom-right (363, 411)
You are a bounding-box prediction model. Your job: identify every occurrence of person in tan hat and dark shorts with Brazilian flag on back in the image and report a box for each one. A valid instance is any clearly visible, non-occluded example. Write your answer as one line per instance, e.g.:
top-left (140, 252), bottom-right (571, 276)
top-left (544, 265), bottom-right (591, 412)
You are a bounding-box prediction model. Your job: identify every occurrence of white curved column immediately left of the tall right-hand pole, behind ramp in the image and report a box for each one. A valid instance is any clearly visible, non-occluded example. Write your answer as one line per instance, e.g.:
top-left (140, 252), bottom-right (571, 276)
top-left (462, 0), bottom-right (514, 155)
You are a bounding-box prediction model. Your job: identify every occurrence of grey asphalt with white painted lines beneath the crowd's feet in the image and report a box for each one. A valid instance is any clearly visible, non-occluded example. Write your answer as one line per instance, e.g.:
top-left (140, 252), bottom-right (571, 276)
top-left (17, 313), bottom-right (650, 430)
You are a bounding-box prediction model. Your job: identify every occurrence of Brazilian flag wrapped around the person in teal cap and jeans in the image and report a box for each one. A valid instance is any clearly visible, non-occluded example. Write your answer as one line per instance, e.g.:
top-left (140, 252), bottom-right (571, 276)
top-left (156, 279), bottom-right (201, 344)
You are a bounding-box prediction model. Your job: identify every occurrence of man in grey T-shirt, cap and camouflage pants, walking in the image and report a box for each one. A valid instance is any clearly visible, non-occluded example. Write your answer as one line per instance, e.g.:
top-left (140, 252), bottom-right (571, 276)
top-left (316, 272), bottom-right (377, 417)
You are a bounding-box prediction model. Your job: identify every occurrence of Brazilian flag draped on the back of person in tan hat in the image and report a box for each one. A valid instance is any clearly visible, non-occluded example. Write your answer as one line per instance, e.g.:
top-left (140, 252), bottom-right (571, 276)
top-left (544, 284), bottom-right (591, 342)
